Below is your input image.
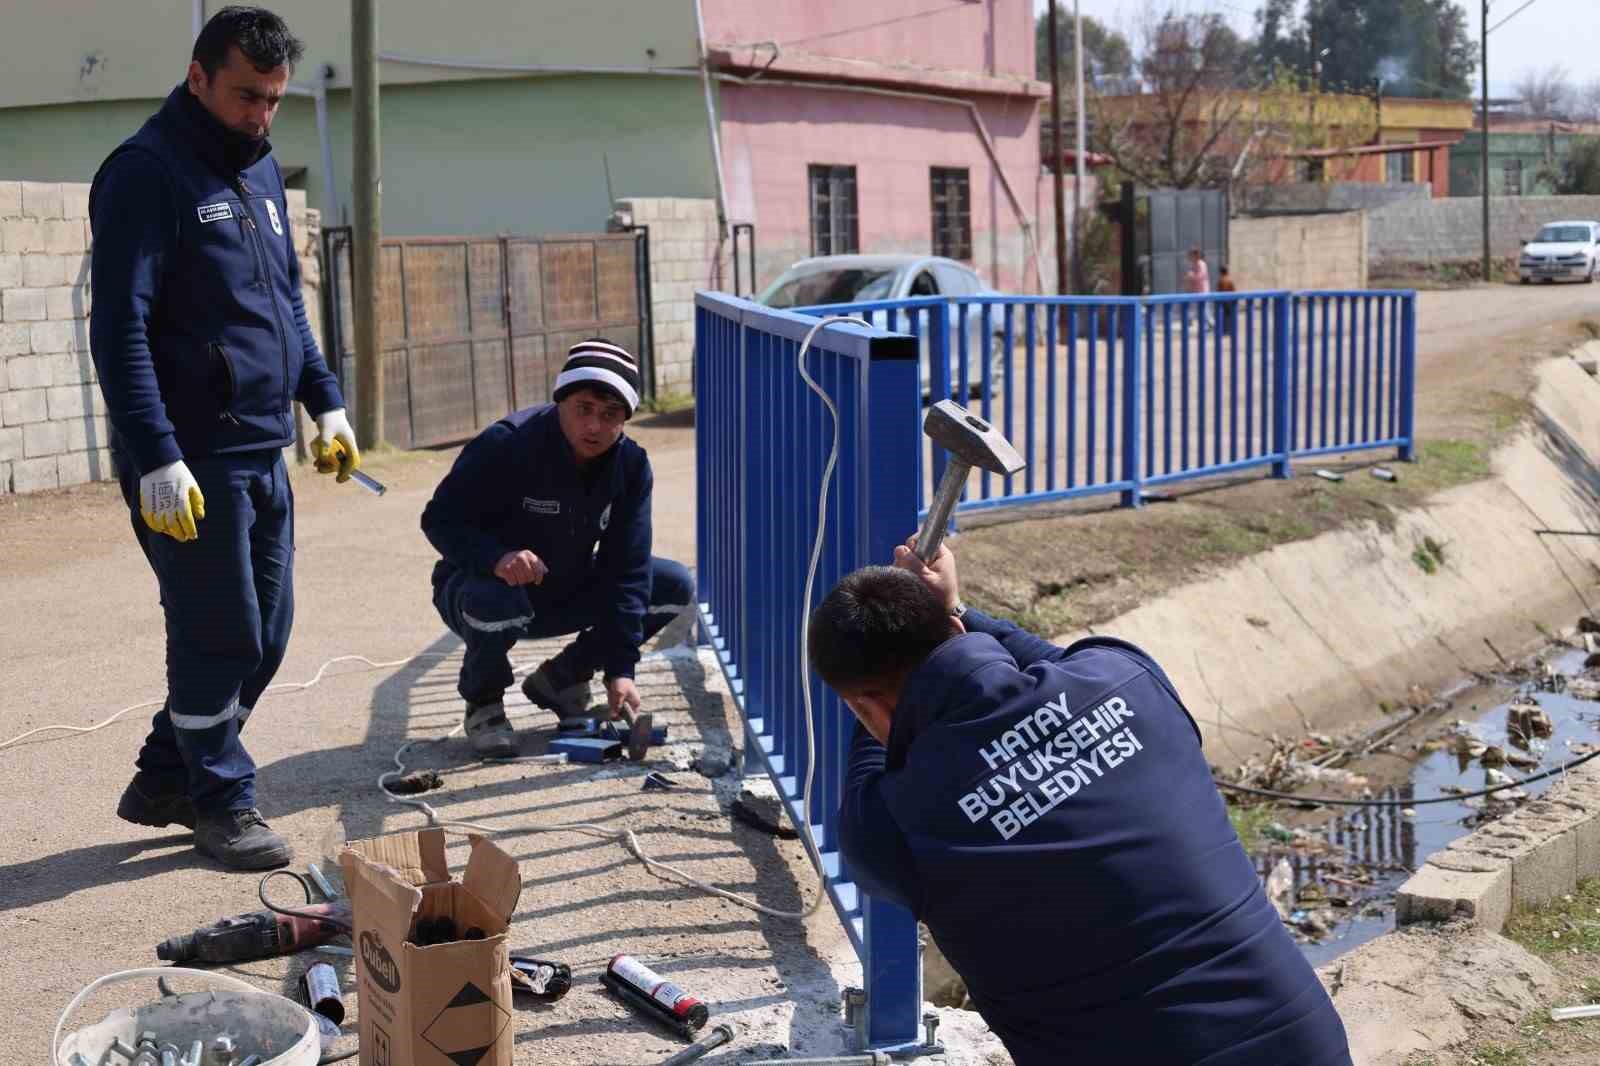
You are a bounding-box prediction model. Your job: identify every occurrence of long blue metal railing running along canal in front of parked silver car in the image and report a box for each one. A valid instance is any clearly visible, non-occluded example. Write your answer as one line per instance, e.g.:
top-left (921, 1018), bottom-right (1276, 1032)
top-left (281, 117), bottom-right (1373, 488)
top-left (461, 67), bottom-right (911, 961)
top-left (803, 291), bottom-right (1416, 511)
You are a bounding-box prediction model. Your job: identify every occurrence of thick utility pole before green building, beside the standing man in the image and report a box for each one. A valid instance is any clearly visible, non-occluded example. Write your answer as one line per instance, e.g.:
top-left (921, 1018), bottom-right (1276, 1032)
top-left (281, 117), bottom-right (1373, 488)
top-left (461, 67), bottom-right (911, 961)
top-left (350, 0), bottom-right (384, 448)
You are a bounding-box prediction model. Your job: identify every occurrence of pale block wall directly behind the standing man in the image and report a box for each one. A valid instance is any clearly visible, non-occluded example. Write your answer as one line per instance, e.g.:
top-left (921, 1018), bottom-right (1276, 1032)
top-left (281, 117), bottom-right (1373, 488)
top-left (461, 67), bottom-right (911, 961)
top-left (0, 181), bottom-right (322, 493)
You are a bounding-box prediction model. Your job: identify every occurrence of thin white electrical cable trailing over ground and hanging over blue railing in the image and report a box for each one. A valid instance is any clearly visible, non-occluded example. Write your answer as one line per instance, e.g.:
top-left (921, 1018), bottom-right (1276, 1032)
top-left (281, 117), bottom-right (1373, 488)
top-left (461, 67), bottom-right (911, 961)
top-left (12, 315), bottom-right (869, 922)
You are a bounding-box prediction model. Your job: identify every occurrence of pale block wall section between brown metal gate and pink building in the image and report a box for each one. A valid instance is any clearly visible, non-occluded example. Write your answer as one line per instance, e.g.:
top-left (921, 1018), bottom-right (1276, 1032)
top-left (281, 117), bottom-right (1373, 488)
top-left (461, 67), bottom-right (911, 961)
top-left (616, 197), bottom-right (733, 394)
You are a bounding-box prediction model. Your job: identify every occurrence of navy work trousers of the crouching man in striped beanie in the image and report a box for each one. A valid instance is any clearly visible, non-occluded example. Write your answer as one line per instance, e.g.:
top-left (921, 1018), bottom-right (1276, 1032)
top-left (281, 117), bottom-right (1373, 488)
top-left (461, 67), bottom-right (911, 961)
top-left (434, 555), bottom-right (694, 706)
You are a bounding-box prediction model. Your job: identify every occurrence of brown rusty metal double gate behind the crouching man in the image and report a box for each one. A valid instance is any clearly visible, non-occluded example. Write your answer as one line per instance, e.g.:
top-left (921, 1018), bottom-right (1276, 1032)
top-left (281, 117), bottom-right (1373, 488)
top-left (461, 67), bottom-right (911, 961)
top-left (322, 226), bottom-right (654, 448)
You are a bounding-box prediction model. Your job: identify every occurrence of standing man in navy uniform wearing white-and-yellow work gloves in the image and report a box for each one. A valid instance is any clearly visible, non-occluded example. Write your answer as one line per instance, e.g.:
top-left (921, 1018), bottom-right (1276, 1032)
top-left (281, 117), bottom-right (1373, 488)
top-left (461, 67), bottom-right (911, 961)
top-left (90, 6), bottom-right (360, 869)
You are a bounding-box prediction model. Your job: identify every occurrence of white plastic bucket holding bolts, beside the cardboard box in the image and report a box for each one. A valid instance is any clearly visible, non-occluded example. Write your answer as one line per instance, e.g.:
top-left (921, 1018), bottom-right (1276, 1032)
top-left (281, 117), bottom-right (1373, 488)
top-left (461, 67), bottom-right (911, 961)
top-left (50, 967), bottom-right (322, 1066)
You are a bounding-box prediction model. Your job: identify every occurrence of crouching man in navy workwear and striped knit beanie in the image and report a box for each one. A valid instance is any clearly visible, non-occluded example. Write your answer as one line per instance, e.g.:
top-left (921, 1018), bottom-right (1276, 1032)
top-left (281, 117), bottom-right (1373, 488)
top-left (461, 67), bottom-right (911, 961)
top-left (422, 339), bottom-right (693, 759)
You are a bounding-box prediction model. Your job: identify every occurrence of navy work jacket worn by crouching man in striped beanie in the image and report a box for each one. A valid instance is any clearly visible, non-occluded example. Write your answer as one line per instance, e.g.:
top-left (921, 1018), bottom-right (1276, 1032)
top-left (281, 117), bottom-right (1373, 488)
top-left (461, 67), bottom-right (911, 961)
top-left (422, 403), bottom-right (654, 677)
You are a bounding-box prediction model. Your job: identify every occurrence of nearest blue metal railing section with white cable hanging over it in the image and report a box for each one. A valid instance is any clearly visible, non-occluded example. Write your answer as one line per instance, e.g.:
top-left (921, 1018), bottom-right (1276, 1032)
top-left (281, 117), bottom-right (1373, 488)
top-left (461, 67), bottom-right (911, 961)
top-left (694, 293), bottom-right (922, 1048)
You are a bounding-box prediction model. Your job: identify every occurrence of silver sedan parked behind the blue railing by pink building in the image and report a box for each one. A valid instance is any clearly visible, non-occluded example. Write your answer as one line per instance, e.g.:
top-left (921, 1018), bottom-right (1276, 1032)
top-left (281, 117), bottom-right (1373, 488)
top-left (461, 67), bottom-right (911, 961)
top-left (755, 254), bottom-right (1000, 392)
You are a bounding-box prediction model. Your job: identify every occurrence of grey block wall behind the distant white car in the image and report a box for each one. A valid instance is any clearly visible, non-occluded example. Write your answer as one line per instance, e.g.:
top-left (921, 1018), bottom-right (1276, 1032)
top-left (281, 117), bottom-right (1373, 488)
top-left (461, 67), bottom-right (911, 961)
top-left (1366, 197), bottom-right (1600, 272)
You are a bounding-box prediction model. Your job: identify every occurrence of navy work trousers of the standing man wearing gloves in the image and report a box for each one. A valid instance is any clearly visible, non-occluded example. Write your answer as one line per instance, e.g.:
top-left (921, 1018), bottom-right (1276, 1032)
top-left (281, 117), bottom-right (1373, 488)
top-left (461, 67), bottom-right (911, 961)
top-left (117, 448), bottom-right (294, 815)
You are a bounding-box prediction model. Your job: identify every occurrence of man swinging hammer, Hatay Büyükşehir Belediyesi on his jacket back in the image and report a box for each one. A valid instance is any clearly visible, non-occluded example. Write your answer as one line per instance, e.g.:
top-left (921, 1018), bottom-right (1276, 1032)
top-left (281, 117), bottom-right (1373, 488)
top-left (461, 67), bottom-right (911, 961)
top-left (808, 547), bottom-right (1350, 1066)
